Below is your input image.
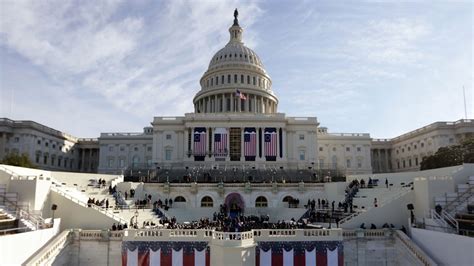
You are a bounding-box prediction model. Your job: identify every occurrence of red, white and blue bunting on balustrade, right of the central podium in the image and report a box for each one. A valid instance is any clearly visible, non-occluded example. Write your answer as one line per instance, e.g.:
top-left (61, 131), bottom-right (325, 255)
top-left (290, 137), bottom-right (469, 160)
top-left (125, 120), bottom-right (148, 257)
top-left (255, 241), bottom-right (344, 266)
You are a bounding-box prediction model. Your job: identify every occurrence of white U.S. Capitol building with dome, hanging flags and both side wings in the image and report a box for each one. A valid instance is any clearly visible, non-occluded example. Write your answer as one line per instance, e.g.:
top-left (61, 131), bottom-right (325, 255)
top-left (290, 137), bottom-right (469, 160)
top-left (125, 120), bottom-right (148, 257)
top-left (0, 11), bottom-right (474, 178)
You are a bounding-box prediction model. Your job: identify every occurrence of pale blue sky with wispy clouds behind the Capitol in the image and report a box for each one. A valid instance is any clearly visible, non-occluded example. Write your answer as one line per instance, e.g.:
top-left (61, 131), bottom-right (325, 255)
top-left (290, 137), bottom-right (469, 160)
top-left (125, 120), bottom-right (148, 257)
top-left (0, 0), bottom-right (474, 138)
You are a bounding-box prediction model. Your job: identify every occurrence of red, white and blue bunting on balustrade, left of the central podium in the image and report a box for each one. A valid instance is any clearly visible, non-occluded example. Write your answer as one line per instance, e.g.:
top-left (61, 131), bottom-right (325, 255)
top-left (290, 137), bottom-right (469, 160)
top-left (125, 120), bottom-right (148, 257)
top-left (122, 241), bottom-right (210, 266)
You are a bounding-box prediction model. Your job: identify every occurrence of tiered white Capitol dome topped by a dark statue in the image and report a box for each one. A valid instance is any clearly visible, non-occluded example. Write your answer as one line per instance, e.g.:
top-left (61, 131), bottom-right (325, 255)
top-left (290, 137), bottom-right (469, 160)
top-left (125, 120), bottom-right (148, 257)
top-left (193, 10), bottom-right (278, 114)
